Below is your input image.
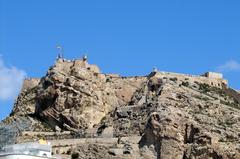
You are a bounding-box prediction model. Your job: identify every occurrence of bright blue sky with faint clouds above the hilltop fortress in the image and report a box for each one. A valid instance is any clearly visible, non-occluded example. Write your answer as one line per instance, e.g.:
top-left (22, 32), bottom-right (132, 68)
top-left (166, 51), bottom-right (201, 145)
top-left (0, 0), bottom-right (240, 119)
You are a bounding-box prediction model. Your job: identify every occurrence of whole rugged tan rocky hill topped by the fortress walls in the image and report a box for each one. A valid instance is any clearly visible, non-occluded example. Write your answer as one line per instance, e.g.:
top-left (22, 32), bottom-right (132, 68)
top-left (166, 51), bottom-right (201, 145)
top-left (0, 59), bottom-right (240, 159)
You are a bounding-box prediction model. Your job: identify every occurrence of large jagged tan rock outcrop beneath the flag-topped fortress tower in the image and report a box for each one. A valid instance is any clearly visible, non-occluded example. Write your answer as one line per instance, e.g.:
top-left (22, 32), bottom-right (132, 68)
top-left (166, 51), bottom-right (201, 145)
top-left (35, 60), bottom-right (144, 130)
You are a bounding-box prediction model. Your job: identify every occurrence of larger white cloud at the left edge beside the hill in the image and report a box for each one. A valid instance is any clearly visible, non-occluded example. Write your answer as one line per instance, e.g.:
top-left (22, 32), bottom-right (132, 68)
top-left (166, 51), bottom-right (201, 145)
top-left (0, 56), bottom-right (26, 100)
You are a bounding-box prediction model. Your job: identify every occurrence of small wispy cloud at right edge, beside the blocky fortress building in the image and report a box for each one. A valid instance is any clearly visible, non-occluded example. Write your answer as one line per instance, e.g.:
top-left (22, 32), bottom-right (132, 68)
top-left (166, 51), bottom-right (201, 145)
top-left (217, 60), bottom-right (240, 72)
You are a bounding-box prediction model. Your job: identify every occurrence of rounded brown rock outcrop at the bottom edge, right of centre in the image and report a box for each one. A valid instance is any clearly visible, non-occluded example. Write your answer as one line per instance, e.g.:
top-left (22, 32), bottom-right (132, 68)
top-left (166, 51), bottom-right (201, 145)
top-left (139, 112), bottom-right (184, 159)
